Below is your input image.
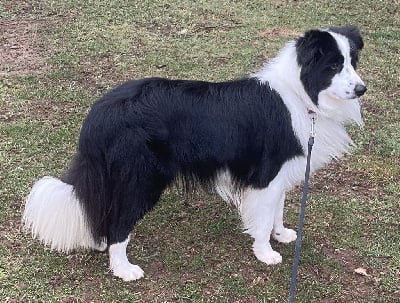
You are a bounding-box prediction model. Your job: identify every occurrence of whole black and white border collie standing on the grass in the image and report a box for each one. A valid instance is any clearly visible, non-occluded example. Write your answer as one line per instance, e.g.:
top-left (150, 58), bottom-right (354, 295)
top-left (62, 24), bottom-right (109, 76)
top-left (23, 26), bottom-right (366, 281)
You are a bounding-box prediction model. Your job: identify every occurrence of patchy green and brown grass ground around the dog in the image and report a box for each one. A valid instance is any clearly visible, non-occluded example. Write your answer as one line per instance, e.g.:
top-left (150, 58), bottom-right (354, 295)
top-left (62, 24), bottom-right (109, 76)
top-left (0, 0), bottom-right (400, 302)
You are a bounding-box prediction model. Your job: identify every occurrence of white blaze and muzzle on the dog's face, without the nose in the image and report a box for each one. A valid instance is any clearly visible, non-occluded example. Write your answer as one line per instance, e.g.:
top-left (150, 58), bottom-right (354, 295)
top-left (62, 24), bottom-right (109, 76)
top-left (320, 32), bottom-right (364, 100)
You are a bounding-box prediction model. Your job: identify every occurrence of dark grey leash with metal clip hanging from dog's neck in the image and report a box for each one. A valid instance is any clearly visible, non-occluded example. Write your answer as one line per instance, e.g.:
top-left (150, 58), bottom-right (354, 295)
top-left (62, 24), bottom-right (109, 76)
top-left (289, 110), bottom-right (316, 303)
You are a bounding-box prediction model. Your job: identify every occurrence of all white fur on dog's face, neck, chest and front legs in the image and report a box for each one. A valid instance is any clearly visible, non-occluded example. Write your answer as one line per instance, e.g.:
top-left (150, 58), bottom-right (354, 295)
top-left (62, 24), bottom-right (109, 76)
top-left (216, 29), bottom-right (364, 264)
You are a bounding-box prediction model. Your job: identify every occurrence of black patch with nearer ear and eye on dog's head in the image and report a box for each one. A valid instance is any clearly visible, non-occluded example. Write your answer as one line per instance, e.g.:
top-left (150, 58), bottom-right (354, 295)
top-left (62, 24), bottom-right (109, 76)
top-left (296, 30), bottom-right (344, 105)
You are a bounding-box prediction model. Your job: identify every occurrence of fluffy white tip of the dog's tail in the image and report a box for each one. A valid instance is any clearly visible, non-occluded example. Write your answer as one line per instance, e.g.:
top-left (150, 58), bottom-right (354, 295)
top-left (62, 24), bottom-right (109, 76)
top-left (22, 177), bottom-right (101, 252)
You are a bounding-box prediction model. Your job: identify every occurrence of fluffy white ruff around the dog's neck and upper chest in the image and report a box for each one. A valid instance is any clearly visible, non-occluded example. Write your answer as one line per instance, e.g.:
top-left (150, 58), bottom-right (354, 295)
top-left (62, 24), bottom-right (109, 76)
top-left (251, 41), bottom-right (357, 170)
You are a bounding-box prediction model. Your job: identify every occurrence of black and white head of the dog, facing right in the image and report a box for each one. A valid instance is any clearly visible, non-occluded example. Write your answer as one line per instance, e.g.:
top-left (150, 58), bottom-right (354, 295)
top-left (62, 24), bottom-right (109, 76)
top-left (296, 26), bottom-right (367, 123)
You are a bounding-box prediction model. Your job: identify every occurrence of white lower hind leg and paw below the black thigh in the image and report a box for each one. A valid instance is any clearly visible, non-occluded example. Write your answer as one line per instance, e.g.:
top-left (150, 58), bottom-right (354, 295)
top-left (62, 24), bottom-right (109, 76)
top-left (108, 237), bottom-right (144, 281)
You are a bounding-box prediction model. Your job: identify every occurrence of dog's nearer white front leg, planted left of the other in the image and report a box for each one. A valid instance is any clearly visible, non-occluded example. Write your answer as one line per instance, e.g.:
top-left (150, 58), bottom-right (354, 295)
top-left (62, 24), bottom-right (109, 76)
top-left (241, 182), bottom-right (284, 265)
